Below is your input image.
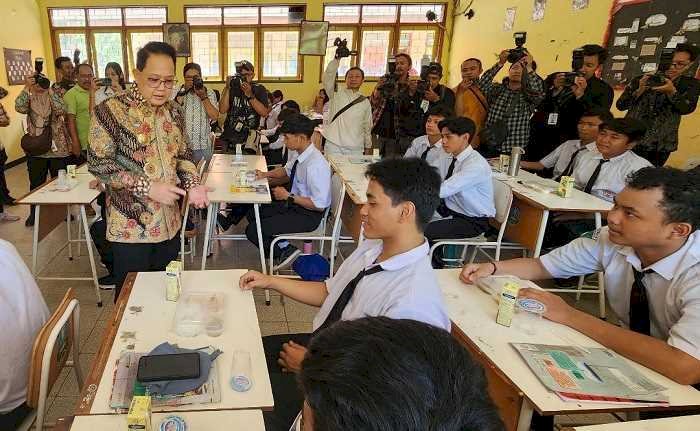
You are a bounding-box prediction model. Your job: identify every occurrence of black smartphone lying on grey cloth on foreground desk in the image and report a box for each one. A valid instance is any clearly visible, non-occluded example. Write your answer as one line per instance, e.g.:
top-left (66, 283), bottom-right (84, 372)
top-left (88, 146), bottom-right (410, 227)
top-left (136, 352), bottom-right (200, 382)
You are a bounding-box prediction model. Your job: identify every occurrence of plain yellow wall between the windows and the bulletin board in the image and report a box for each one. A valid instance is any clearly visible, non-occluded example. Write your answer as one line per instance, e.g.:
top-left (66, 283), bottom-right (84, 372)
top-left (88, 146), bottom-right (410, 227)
top-left (449, 0), bottom-right (700, 168)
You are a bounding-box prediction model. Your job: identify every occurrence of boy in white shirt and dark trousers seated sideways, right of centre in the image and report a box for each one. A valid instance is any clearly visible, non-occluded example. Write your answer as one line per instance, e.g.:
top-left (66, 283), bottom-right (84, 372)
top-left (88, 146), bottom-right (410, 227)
top-left (425, 117), bottom-right (496, 268)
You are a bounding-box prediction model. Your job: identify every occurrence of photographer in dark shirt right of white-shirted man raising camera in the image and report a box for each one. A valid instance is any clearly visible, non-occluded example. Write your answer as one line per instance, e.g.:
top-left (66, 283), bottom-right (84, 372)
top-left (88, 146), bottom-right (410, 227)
top-left (370, 53), bottom-right (424, 157)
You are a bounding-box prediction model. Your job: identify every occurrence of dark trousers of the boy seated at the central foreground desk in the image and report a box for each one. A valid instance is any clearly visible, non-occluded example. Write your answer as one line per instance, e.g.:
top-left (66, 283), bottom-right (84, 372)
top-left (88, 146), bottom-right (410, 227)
top-left (263, 334), bottom-right (311, 431)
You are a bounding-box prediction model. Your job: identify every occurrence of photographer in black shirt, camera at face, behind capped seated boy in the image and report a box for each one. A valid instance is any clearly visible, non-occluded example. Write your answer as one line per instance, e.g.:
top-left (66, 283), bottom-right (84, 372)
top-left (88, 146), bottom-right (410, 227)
top-left (219, 60), bottom-right (270, 152)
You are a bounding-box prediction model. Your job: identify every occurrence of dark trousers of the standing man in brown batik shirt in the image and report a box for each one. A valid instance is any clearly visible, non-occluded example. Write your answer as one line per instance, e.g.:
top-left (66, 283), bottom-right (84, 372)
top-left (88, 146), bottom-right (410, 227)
top-left (112, 232), bottom-right (180, 302)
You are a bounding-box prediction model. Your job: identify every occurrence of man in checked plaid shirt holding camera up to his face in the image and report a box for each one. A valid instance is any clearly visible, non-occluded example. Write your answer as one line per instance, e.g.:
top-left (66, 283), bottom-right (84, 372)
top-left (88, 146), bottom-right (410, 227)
top-left (479, 49), bottom-right (544, 153)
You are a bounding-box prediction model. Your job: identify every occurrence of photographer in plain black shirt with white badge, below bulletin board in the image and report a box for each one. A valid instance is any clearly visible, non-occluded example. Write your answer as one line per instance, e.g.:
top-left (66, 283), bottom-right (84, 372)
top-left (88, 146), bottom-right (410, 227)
top-left (528, 44), bottom-right (614, 160)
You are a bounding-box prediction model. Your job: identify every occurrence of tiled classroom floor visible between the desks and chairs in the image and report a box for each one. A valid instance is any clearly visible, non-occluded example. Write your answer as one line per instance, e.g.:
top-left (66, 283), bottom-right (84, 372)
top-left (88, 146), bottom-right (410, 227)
top-left (0, 164), bottom-right (615, 425)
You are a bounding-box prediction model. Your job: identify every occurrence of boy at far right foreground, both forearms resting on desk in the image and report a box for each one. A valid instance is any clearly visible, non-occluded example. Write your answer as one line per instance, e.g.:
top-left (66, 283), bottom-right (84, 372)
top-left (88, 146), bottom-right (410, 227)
top-left (460, 167), bottom-right (700, 385)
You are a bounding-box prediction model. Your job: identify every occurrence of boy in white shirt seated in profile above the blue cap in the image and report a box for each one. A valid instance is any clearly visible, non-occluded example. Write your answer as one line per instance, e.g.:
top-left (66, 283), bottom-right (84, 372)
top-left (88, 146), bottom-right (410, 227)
top-left (219, 114), bottom-right (331, 268)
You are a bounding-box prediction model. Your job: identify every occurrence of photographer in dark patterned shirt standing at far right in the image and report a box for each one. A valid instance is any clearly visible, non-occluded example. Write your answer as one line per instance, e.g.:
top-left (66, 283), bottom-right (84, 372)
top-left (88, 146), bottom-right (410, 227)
top-left (617, 43), bottom-right (700, 166)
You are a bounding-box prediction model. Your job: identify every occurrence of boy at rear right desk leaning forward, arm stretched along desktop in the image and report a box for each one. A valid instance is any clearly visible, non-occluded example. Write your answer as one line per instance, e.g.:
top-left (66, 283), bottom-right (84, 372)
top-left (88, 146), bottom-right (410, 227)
top-left (520, 111), bottom-right (613, 181)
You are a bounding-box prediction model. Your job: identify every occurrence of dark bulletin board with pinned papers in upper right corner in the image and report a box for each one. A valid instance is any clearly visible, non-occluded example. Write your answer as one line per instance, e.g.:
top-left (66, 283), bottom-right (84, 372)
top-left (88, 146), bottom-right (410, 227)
top-left (602, 0), bottom-right (700, 88)
